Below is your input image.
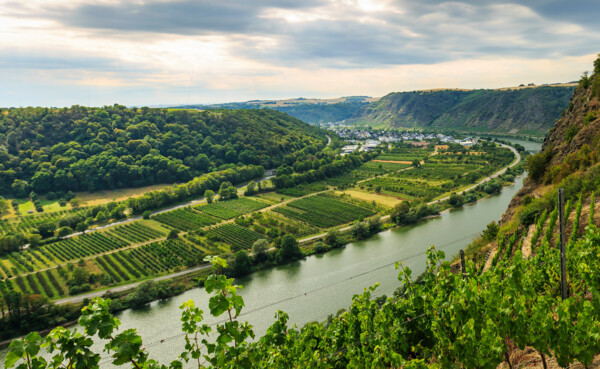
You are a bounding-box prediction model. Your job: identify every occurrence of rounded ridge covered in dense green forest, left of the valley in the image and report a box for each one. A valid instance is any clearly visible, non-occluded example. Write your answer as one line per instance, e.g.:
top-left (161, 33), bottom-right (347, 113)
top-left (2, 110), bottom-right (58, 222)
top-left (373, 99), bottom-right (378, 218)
top-left (0, 105), bottom-right (327, 197)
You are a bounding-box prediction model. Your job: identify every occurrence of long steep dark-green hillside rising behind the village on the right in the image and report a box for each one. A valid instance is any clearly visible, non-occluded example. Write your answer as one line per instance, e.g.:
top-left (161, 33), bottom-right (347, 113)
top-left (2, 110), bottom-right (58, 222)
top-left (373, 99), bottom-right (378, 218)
top-left (352, 86), bottom-right (573, 135)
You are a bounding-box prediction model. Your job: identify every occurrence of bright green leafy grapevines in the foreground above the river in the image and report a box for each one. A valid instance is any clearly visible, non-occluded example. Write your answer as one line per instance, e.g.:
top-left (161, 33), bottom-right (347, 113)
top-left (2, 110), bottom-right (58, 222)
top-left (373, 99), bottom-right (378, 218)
top-left (6, 217), bottom-right (600, 368)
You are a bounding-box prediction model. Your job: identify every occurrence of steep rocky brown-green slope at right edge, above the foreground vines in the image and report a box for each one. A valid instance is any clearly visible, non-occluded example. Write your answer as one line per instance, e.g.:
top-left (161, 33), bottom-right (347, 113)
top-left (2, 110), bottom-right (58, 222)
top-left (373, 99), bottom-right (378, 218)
top-left (502, 58), bottom-right (600, 223)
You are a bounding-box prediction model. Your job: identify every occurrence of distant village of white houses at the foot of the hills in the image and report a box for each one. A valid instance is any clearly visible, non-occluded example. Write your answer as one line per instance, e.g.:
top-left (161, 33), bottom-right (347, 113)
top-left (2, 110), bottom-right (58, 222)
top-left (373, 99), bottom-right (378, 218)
top-left (334, 128), bottom-right (477, 155)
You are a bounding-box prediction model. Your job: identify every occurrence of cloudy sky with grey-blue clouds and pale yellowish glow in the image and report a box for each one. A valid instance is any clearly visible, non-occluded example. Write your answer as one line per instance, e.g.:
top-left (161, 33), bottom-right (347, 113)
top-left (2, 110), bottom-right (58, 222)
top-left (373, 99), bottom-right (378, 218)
top-left (0, 0), bottom-right (600, 106)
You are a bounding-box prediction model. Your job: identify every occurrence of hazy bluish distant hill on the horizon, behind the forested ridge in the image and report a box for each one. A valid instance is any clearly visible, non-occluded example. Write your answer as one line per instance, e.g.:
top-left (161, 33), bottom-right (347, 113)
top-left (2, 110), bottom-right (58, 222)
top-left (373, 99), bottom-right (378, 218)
top-left (172, 96), bottom-right (377, 124)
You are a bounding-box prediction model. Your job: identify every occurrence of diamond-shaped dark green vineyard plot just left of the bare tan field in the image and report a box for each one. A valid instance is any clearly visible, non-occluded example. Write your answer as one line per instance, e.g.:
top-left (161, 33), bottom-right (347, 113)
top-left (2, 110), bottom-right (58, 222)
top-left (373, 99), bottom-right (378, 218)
top-left (274, 195), bottom-right (375, 228)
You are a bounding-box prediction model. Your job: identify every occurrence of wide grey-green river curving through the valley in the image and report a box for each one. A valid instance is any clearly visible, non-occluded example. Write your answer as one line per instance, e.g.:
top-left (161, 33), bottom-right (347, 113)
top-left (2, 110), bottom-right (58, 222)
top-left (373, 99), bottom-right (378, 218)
top-left (0, 141), bottom-right (541, 368)
